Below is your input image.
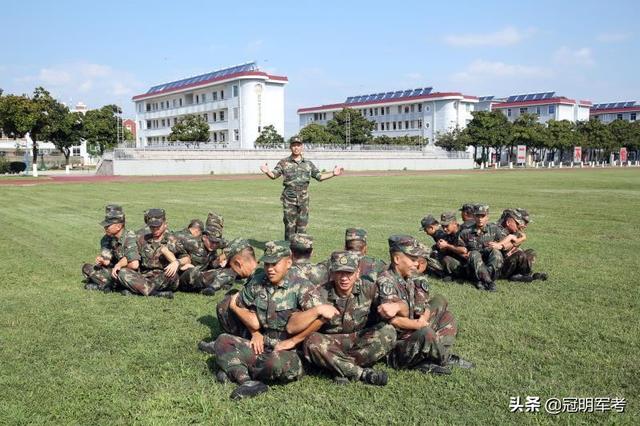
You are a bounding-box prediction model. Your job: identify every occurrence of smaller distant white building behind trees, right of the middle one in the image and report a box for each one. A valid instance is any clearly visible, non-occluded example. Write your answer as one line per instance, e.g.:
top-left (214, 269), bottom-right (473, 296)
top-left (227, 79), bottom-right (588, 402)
top-left (478, 92), bottom-right (592, 123)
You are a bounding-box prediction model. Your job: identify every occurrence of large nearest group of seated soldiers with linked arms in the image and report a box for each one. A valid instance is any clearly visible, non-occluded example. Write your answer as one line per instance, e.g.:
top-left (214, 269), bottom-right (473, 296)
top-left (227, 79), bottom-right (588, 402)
top-left (198, 228), bottom-right (473, 399)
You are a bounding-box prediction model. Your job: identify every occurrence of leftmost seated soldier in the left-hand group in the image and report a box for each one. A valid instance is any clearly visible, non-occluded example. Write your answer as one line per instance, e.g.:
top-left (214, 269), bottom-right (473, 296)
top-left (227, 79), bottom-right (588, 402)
top-left (82, 204), bottom-right (140, 292)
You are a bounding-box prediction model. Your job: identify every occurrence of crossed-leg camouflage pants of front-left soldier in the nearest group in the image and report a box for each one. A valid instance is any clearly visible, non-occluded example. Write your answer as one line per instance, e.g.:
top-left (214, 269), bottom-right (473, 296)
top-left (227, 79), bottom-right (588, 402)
top-left (213, 333), bottom-right (303, 383)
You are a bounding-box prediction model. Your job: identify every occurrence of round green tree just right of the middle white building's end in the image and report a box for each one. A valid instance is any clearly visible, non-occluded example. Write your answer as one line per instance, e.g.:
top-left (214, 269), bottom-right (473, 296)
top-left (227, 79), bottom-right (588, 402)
top-left (466, 111), bottom-right (511, 161)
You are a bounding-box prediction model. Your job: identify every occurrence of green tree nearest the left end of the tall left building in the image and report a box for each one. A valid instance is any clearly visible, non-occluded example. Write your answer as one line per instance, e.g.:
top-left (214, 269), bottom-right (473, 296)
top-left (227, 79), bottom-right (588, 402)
top-left (83, 105), bottom-right (120, 155)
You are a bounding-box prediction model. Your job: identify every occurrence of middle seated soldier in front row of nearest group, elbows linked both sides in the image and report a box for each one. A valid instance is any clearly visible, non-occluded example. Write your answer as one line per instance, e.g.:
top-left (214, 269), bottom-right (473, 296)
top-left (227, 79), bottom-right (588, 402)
top-left (296, 251), bottom-right (406, 386)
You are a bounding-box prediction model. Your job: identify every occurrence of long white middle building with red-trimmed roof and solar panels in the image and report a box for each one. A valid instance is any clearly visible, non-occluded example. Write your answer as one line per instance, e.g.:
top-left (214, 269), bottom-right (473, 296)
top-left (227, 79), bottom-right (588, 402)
top-left (298, 87), bottom-right (478, 144)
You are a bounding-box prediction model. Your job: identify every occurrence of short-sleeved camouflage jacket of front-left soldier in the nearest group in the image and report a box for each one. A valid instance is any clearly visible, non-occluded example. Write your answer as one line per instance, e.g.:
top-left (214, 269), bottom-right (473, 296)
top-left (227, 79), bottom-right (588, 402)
top-left (238, 271), bottom-right (320, 339)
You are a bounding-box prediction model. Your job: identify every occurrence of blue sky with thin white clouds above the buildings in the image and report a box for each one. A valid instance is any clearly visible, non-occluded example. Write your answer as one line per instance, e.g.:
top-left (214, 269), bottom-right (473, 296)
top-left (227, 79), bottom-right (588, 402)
top-left (0, 0), bottom-right (640, 136)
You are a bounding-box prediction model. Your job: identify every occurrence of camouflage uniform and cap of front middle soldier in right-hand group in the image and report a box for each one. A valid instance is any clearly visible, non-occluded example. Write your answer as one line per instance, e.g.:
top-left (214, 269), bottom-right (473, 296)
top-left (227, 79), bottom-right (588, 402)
top-left (456, 204), bottom-right (506, 283)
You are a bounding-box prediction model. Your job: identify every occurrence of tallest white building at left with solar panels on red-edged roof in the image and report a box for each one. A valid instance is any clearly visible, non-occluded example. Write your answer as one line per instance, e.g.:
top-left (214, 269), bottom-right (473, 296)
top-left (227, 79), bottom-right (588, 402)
top-left (133, 62), bottom-right (288, 149)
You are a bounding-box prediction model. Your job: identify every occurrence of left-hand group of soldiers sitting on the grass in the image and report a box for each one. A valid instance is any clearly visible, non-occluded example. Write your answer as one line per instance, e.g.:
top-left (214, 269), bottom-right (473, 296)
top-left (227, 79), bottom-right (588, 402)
top-left (82, 204), bottom-right (236, 298)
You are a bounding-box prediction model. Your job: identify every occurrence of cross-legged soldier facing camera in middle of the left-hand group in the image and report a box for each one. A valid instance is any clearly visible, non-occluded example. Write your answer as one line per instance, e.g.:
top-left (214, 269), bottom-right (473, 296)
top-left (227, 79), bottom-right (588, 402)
top-left (118, 209), bottom-right (180, 299)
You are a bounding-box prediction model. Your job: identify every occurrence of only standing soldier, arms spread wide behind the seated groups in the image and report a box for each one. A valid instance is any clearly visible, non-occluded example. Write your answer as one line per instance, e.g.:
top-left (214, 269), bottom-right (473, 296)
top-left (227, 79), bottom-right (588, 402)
top-left (260, 136), bottom-right (343, 241)
